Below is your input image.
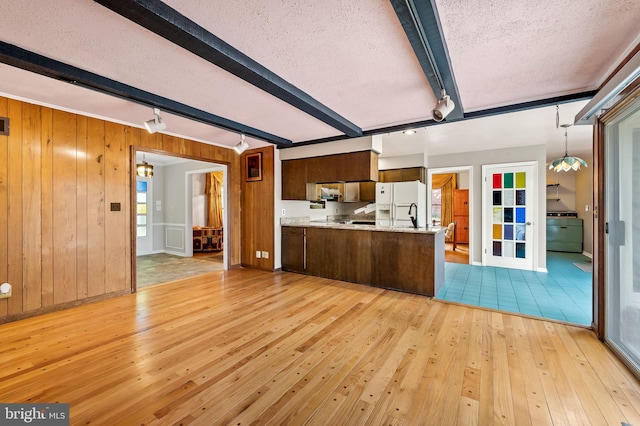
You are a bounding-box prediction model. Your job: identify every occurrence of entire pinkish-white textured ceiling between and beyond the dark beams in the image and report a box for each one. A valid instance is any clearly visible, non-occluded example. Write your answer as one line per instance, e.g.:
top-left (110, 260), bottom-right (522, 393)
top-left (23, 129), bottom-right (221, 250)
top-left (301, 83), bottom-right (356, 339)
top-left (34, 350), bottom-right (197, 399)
top-left (0, 0), bottom-right (640, 156)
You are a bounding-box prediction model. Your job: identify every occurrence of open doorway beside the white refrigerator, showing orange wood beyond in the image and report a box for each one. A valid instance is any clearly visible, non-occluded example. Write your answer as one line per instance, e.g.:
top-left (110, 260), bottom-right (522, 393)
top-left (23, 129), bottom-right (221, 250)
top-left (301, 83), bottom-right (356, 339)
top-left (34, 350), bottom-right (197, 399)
top-left (427, 167), bottom-right (472, 264)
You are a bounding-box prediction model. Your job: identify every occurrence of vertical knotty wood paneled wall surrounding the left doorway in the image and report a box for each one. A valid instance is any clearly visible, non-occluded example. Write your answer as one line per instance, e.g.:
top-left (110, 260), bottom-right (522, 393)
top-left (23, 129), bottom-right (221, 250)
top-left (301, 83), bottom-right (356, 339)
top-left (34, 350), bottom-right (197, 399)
top-left (0, 97), bottom-right (244, 322)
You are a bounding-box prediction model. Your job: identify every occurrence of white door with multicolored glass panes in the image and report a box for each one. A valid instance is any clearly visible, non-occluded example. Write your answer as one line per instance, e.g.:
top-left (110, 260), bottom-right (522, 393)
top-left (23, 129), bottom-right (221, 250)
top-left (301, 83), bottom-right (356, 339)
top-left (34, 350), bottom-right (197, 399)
top-left (482, 162), bottom-right (537, 270)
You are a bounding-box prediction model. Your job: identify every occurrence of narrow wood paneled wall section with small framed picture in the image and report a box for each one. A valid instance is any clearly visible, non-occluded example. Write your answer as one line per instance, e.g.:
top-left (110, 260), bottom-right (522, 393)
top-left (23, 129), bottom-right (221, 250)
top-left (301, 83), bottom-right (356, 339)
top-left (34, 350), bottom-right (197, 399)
top-left (241, 146), bottom-right (275, 271)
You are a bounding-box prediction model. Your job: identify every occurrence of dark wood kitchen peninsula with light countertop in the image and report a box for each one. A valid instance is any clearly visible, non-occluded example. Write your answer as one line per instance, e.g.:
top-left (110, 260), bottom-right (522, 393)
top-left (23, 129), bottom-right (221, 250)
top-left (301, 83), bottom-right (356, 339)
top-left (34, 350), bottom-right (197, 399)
top-left (281, 218), bottom-right (444, 297)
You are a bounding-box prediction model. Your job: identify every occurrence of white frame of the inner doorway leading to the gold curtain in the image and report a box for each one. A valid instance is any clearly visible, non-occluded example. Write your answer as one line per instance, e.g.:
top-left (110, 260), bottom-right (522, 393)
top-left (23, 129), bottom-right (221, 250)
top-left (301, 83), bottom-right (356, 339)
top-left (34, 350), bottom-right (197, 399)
top-left (184, 163), bottom-right (229, 270)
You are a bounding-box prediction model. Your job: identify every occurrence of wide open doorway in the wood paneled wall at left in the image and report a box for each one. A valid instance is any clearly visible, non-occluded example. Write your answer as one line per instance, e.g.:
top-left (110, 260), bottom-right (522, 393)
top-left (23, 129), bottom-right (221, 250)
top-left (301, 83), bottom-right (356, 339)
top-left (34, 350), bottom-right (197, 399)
top-left (132, 151), bottom-right (228, 291)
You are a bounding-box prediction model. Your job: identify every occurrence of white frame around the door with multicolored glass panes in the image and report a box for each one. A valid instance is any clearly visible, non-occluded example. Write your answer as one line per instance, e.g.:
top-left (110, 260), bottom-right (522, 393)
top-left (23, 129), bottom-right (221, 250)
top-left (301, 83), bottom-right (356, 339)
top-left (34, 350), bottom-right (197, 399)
top-left (482, 161), bottom-right (543, 271)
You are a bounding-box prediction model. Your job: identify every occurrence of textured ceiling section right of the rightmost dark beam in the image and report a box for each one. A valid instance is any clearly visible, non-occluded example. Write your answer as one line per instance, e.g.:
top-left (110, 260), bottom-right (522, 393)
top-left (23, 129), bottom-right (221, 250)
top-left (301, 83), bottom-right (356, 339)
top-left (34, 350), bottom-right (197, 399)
top-left (436, 0), bottom-right (640, 111)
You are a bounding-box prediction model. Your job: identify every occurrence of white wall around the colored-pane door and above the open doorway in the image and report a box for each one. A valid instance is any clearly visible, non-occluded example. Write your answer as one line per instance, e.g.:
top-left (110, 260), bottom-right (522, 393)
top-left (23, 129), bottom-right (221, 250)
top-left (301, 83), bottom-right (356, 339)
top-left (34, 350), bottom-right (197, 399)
top-left (427, 145), bottom-right (547, 270)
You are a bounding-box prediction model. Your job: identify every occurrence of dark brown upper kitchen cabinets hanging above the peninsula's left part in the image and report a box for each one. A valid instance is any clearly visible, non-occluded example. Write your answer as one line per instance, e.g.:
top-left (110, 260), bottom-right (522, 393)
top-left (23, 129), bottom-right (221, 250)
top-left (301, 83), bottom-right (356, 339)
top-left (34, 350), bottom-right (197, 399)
top-left (282, 151), bottom-right (378, 200)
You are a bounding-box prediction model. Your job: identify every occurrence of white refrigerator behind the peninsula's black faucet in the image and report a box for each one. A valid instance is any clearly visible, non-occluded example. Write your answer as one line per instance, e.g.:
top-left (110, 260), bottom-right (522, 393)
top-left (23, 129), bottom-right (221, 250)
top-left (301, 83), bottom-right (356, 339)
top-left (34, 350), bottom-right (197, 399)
top-left (376, 180), bottom-right (427, 228)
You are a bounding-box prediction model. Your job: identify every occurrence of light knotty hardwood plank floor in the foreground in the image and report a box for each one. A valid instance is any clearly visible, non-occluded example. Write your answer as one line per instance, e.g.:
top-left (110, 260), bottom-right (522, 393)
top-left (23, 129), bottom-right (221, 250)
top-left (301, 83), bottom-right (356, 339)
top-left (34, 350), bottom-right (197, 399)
top-left (0, 269), bottom-right (640, 426)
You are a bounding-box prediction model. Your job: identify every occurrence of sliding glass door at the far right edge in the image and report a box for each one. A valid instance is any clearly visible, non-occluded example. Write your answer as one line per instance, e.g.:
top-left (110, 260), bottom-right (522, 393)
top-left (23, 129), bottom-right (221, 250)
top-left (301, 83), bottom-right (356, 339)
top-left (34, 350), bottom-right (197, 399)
top-left (604, 101), bottom-right (640, 372)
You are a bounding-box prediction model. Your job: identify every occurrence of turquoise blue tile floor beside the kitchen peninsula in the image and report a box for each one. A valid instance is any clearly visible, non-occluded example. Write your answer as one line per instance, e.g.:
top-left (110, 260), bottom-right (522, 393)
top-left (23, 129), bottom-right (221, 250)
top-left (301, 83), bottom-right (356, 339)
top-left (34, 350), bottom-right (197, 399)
top-left (436, 252), bottom-right (592, 326)
